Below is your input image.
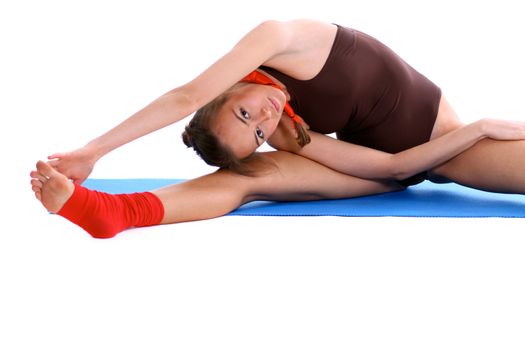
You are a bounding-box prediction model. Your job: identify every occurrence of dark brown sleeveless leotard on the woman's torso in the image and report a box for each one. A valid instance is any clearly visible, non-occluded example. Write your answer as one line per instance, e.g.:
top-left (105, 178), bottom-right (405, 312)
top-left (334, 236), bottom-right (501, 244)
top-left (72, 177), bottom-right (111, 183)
top-left (261, 26), bottom-right (441, 185)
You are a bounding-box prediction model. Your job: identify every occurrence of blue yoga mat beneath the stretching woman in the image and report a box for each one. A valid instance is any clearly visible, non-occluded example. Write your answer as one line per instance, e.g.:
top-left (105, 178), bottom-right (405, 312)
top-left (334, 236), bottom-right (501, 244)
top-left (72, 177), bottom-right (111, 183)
top-left (84, 179), bottom-right (525, 218)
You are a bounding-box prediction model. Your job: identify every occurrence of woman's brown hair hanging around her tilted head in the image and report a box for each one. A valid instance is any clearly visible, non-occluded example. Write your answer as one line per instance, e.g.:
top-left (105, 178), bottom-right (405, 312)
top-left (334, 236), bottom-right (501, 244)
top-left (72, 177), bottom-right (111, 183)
top-left (182, 87), bottom-right (310, 176)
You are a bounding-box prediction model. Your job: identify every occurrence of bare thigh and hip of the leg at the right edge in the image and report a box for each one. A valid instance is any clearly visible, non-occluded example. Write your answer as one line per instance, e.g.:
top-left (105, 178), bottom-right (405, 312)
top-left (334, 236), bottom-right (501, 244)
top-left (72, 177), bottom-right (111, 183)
top-left (429, 98), bottom-right (525, 194)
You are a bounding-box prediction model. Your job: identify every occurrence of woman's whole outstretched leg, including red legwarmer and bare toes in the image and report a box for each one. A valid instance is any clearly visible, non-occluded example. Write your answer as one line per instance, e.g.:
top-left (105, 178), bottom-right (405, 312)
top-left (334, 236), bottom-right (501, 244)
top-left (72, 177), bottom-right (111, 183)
top-left (31, 152), bottom-right (402, 238)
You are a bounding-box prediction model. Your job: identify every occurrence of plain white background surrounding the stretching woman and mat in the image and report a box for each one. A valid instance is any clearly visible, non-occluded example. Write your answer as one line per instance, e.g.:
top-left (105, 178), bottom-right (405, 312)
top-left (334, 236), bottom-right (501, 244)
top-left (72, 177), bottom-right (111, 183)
top-left (0, 0), bottom-right (525, 349)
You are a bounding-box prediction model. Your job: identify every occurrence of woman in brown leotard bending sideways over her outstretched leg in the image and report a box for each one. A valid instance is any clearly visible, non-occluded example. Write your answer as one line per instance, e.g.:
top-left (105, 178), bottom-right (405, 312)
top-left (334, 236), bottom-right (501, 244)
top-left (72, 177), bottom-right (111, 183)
top-left (31, 20), bottom-right (525, 237)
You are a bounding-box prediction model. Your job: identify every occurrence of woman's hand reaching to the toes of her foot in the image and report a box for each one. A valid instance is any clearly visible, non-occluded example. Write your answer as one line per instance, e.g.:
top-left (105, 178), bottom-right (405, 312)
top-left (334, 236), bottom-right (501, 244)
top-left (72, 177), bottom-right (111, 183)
top-left (47, 147), bottom-right (97, 185)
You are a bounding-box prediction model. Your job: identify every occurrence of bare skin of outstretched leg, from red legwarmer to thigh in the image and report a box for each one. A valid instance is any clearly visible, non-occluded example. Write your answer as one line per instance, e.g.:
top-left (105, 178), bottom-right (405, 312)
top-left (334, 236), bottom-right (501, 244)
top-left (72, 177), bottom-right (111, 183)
top-left (153, 152), bottom-right (403, 223)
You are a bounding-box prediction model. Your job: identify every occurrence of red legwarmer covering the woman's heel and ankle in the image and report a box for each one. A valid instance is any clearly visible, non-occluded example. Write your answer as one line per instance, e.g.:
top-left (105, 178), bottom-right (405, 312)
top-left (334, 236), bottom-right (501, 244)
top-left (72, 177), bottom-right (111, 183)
top-left (57, 184), bottom-right (164, 238)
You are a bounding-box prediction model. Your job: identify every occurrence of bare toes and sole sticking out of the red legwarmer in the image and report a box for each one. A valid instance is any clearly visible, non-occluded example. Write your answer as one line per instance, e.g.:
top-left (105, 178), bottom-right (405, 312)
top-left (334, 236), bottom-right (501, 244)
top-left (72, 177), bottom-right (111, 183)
top-left (30, 160), bottom-right (75, 213)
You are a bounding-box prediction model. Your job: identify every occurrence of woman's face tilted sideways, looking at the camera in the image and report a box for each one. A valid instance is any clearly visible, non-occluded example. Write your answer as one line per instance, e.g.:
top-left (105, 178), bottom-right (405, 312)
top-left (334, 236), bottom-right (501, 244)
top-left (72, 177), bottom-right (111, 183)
top-left (212, 84), bottom-right (286, 159)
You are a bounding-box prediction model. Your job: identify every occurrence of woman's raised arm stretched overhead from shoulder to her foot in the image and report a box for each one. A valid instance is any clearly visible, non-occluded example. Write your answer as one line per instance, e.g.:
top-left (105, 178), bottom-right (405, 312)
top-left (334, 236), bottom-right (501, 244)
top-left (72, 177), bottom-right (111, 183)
top-left (48, 21), bottom-right (299, 183)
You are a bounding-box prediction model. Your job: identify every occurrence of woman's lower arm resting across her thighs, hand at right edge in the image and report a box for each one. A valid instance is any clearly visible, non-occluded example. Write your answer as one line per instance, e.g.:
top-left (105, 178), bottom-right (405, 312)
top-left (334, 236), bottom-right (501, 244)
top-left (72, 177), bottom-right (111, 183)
top-left (272, 119), bottom-right (525, 180)
